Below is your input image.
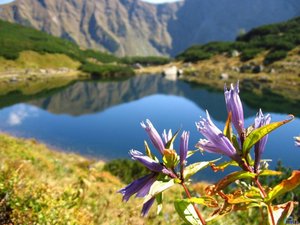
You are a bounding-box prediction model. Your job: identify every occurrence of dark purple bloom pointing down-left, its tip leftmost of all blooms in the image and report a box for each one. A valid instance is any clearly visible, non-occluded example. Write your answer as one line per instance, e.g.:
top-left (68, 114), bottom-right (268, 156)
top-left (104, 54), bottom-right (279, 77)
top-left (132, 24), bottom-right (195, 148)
top-left (118, 173), bottom-right (158, 202)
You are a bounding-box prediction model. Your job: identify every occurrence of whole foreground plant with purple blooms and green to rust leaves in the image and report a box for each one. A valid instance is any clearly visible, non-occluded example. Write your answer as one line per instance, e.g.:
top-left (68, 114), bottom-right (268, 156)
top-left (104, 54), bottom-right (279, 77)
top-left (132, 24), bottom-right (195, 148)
top-left (119, 83), bottom-right (300, 225)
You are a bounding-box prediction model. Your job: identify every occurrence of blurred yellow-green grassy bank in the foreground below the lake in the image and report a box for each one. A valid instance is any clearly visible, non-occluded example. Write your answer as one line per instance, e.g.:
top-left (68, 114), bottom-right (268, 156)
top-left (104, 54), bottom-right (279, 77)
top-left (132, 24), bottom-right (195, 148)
top-left (0, 133), bottom-right (264, 225)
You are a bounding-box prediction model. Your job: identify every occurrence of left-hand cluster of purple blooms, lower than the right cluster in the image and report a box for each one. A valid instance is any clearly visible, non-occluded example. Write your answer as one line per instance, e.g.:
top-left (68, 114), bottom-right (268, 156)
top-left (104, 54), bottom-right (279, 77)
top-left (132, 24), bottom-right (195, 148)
top-left (119, 119), bottom-right (189, 216)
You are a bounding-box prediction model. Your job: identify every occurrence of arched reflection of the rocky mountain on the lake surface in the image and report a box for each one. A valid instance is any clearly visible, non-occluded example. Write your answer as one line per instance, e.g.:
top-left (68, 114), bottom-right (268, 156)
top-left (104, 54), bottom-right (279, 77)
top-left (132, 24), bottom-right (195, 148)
top-left (28, 75), bottom-right (256, 121)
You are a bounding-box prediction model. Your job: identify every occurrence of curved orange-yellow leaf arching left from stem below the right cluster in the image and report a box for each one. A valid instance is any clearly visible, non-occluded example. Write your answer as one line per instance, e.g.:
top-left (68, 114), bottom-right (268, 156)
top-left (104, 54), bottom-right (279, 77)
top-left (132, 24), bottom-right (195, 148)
top-left (210, 171), bottom-right (256, 194)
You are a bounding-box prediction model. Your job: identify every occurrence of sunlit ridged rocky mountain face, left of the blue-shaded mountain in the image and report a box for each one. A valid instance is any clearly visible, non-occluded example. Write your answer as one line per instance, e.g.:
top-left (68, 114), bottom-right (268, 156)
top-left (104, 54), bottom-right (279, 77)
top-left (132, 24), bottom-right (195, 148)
top-left (0, 0), bottom-right (180, 55)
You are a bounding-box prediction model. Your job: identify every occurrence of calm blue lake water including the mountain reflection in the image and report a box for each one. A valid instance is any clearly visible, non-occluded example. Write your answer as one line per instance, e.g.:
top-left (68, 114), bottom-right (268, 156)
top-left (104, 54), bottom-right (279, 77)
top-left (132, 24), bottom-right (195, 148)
top-left (0, 76), bottom-right (300, 180)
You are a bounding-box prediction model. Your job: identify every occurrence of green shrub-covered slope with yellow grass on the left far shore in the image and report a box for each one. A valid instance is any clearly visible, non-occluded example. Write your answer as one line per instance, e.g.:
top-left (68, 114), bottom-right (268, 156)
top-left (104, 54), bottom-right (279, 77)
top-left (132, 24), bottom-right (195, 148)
top-left (0, 20), bottom-right (134, 78)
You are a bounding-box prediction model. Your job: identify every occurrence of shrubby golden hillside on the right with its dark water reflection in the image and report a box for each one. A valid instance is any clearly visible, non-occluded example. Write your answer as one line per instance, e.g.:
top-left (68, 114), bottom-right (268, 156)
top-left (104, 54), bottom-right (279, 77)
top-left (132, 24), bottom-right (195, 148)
top-left (171, 17), bottom-right (300, 112)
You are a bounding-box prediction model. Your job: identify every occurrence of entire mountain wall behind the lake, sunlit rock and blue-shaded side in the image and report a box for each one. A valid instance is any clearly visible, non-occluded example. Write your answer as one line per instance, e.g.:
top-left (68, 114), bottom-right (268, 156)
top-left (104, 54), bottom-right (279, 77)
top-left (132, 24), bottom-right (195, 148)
top-left (0, 0), bottom-right (300, 55)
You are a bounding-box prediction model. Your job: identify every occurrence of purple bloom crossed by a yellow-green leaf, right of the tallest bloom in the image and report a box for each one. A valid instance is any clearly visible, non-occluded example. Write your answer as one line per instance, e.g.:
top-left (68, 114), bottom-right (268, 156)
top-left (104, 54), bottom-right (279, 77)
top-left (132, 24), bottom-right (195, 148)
top-left (254, 109), bottom-right (271, 172)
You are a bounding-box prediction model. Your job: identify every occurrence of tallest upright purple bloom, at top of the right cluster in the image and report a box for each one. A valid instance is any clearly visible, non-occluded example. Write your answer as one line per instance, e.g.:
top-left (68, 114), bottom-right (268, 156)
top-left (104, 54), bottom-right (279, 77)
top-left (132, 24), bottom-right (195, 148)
top-left (224, 82), bottom-right (244, 136)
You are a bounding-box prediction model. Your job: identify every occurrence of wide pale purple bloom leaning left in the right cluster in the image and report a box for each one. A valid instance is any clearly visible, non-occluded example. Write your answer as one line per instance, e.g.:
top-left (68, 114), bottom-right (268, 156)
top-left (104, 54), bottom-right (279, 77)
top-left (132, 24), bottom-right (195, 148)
top-left (196, 111), bottom-right (241, 163)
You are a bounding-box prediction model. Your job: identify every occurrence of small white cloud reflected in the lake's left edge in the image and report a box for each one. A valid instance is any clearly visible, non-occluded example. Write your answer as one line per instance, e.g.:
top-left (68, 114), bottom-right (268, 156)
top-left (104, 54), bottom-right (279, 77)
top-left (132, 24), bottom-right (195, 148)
top-left (7, 104), bottom-right (38, 126)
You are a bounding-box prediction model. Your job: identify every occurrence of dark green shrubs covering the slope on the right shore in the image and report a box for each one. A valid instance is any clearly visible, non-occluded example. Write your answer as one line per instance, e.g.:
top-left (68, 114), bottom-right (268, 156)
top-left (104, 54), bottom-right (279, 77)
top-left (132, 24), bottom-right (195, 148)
top-left (176, 17), bottom-right (300, 64)
